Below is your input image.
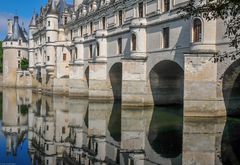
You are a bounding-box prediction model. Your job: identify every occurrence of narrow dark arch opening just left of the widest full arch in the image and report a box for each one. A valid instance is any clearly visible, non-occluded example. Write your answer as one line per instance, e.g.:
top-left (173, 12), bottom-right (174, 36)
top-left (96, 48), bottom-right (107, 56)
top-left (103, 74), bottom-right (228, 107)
top-left (109, 62), bottom-right (122, 100)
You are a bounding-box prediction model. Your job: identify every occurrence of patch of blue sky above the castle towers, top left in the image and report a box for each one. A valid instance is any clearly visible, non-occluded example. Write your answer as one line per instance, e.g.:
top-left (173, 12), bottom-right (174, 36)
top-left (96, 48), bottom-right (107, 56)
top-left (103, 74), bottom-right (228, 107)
top-left (0, 0), bottom-right (72, 40)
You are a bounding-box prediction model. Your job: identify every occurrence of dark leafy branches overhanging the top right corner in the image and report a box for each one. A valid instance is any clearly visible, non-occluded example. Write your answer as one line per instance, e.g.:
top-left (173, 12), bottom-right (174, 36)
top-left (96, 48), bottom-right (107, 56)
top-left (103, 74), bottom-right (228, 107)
top-left (180, 0), bottom-right (240, 61)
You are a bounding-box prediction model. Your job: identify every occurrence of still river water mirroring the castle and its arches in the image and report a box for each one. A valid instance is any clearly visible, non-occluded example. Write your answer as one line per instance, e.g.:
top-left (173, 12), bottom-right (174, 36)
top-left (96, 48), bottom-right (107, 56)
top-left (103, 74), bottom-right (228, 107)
top-left (0, 89), bottom-right (240, 165)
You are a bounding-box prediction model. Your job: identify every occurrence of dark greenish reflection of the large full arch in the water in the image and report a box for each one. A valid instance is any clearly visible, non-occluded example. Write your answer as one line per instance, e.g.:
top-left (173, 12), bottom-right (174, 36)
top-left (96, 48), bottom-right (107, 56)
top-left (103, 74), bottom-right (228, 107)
top-left (148, 106), bottom-right (183, 158)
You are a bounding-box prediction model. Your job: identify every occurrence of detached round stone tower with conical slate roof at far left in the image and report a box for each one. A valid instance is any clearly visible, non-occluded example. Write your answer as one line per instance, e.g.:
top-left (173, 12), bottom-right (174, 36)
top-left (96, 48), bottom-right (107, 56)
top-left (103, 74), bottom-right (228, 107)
top-left (3, 16), bottom-right (28, 87)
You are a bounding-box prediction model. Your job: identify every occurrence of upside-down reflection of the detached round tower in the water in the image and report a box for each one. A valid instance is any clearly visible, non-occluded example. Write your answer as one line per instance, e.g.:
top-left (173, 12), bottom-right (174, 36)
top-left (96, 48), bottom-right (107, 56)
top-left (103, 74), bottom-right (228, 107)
top-left (2, 89), bottom-right (32, 156)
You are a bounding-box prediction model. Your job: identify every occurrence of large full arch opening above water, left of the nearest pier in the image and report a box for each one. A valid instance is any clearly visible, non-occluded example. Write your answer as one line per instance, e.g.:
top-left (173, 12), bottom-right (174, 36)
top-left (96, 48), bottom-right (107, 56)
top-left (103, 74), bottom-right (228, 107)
top-left (149, 60), bottom-right (184, 105)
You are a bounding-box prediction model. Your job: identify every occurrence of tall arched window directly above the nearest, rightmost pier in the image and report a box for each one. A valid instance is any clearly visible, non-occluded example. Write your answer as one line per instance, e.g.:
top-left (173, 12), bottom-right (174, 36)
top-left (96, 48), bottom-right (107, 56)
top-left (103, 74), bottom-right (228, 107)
top-left (193, 18), bottom-right (202, 42)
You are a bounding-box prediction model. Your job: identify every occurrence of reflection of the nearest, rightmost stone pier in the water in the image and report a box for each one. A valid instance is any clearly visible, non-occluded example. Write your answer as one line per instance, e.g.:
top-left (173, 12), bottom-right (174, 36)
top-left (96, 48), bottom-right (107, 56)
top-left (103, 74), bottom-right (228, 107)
top-left (183, 118), bottom-right (225, 165)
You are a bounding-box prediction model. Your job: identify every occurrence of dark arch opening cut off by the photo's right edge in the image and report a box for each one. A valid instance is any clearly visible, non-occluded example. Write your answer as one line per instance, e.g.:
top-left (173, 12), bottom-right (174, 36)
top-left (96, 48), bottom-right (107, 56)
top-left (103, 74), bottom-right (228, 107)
top-left (222, 59), bottom-right (240, 116)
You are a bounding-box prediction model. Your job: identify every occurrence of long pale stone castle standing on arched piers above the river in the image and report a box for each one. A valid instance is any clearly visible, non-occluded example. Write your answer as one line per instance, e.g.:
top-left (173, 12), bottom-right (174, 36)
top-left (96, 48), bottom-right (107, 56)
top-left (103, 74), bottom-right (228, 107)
top-left (4, 0), bottom-right (239, 116)
